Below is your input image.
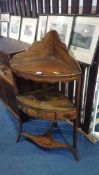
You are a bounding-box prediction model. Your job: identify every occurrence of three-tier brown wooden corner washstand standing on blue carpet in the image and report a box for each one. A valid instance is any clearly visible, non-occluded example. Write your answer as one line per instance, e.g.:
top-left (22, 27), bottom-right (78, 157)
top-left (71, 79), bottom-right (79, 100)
top-left (10, 31), bottom-right (81, 160)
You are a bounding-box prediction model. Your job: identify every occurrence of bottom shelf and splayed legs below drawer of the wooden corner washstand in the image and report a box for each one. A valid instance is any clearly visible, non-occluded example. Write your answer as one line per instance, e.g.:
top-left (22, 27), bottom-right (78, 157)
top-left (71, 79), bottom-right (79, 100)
top-left (17, 123), bottom-right (79, 161)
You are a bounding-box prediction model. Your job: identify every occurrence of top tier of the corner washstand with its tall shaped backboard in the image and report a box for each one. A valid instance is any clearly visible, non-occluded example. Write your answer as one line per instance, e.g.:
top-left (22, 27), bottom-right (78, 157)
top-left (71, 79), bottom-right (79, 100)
top-left (10, 30), bottom-right (81, 82)
